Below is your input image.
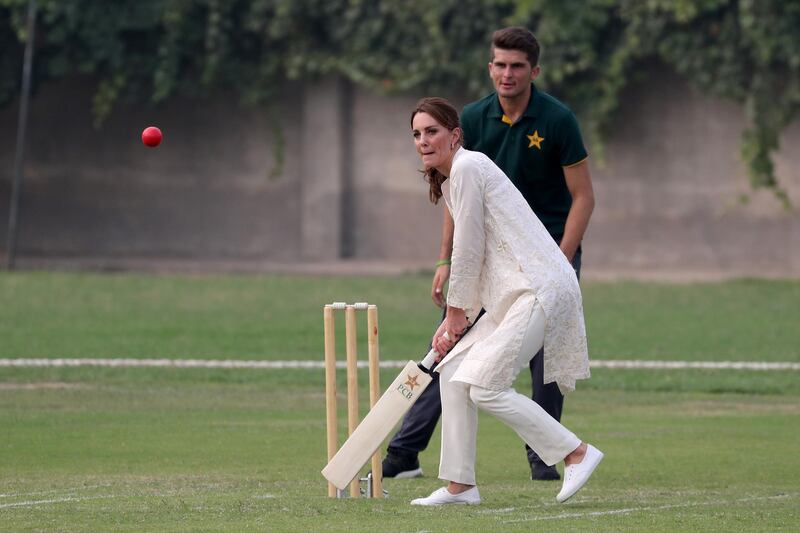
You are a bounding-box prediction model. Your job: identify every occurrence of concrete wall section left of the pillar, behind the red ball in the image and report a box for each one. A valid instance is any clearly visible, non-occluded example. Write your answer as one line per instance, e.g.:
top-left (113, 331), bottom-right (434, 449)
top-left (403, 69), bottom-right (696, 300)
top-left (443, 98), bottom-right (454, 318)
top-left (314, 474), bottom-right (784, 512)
top-left (0, 76), bottom-right (302, 260)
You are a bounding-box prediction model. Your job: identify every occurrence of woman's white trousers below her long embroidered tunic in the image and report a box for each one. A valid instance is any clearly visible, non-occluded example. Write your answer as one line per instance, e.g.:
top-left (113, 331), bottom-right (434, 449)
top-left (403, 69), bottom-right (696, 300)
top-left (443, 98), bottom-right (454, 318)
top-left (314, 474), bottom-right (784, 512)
top-left (439, 302), bottom-right (581, 485)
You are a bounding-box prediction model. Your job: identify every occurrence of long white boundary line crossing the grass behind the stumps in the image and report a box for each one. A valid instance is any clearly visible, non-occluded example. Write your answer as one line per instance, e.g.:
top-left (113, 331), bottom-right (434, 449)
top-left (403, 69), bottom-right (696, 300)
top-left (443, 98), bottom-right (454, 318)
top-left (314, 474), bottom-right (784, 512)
top-left (0, 358), bottom-right (800, 370)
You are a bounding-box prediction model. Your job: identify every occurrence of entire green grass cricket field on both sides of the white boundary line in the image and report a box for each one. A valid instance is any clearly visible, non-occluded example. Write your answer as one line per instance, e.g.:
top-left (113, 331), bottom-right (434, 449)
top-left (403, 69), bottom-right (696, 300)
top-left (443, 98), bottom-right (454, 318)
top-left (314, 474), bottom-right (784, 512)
top-left (0, 272), bottom-right (800, 531)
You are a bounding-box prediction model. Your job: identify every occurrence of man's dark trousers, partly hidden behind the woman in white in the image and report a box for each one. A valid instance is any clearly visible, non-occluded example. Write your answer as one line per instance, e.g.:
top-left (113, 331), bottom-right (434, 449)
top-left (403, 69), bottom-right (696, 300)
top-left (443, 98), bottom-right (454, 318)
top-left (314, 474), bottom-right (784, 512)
top-left (389, 245), bottom-right (582, 462)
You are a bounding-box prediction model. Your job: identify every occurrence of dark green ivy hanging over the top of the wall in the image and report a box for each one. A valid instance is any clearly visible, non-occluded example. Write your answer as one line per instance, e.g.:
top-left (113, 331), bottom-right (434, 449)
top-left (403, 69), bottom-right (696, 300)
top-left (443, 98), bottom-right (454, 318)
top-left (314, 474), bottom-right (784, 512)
top-left (0, 0), bottom-right (800, 206)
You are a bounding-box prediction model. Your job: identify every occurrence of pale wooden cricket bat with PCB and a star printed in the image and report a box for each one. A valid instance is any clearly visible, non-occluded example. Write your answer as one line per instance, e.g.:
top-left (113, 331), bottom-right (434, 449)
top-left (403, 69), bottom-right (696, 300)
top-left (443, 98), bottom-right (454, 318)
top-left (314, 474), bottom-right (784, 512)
top-left (322, 340), bottom-right (439, 490)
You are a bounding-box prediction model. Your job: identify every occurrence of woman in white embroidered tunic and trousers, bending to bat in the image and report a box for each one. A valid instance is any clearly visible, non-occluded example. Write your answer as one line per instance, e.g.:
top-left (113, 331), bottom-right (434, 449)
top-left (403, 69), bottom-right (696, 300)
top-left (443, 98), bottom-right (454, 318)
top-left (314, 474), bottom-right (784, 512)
top-left (411, 98), bottom-right (603, 505)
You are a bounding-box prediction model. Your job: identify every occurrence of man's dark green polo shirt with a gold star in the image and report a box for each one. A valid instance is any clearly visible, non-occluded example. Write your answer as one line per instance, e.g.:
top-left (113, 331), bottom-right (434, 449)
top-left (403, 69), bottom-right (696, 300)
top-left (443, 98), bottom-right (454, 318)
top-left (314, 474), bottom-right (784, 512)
top-left (461, 84), bottom-right (587, 238)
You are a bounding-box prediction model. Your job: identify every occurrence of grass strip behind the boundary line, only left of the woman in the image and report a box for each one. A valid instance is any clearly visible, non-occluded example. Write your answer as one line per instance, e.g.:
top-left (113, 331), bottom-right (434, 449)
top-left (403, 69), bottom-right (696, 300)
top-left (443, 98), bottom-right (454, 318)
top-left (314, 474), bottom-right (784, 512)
top-left (0, 272), bottom-right (439, 359)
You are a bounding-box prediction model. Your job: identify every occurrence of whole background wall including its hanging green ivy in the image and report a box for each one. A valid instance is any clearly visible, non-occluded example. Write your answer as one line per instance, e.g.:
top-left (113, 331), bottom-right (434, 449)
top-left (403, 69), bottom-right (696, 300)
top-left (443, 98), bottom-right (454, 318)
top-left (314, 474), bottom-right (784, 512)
top-left (0, 0), bottom-right (800, 276)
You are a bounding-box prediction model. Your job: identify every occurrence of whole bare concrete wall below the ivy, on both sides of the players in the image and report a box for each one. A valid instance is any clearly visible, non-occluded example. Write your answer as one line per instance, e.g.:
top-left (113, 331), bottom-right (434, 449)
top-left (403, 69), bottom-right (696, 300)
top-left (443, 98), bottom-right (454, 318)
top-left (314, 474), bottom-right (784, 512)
top-left (0, 70), bottom-right (800, 278)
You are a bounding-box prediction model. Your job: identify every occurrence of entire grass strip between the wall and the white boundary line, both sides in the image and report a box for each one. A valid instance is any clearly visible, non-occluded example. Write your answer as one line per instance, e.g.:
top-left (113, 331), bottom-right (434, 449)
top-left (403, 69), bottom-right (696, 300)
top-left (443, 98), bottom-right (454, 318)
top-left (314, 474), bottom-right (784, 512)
top-left (0, 272), bottom-right (800, 361)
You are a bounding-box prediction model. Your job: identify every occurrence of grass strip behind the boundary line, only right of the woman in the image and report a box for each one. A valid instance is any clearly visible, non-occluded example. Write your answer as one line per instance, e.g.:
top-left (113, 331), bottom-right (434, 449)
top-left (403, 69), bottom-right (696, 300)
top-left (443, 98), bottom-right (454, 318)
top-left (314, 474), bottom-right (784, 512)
top-left (583, 280), bottom-right (800, 361)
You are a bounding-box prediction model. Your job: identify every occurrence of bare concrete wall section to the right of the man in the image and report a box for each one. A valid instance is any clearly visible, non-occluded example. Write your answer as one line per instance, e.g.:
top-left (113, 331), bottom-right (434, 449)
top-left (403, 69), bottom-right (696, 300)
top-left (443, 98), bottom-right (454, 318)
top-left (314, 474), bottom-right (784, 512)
top-left (586, 71), bottom-right (800, 277)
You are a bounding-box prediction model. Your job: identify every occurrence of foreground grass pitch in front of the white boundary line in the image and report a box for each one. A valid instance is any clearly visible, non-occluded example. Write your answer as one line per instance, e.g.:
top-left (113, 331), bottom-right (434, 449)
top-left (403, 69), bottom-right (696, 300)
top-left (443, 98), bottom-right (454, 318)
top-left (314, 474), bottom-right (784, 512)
top-left (0, 369), bottom-right (800, 531)
